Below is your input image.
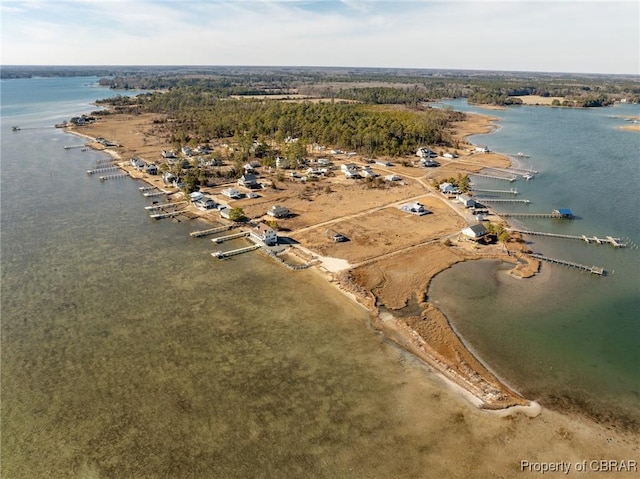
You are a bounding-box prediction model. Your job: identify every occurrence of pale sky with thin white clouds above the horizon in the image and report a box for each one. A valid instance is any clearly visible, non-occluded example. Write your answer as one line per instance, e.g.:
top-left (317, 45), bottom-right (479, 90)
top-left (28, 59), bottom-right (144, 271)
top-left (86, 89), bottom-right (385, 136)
top-left (0, 0), bottom-right (640, 75)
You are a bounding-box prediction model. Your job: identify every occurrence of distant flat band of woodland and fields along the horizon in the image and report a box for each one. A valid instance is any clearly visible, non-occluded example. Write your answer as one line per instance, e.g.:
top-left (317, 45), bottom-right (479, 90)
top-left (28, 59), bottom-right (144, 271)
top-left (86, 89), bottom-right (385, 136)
top-left (94, 67), bottom-right (640, 107)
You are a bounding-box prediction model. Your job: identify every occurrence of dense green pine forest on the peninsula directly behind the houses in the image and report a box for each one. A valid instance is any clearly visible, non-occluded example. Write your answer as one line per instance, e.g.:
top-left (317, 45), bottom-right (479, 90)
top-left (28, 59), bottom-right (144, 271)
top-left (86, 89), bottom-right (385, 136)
top-left (116, 87), bottom-right (464, 156)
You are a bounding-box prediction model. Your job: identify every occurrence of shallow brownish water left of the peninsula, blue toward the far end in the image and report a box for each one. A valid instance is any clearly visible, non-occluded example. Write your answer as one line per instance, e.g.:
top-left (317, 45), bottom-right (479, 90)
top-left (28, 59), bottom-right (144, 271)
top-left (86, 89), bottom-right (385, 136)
top-left (0, 78), bottom-right (470, 479)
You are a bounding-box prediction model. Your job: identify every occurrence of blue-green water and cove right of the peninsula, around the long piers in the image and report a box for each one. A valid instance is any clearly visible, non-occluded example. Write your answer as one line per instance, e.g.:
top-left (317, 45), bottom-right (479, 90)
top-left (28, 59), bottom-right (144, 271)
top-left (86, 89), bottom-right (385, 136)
top-left (428, 100), bottom-right (640, 431)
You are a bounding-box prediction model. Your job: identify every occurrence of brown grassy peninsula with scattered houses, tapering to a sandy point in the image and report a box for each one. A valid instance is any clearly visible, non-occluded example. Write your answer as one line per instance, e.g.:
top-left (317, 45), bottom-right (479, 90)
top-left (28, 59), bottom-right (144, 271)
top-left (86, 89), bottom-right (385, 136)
top-left (68, 83), bottom-right (539, 415)
